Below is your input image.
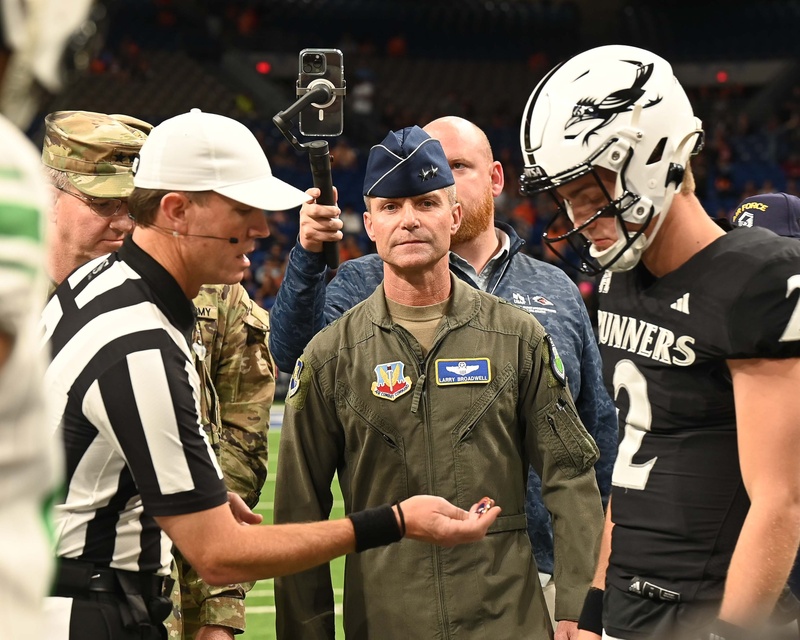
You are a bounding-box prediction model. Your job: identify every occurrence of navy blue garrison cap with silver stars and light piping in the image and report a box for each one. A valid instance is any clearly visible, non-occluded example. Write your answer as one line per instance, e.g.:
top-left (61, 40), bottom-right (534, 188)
top-left (364, 126), bottom-right (455, 198)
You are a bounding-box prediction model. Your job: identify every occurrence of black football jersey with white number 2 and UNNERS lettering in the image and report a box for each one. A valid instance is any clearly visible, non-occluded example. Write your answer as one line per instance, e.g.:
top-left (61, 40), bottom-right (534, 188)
top-left (598, 229), bottom-right (800, 601)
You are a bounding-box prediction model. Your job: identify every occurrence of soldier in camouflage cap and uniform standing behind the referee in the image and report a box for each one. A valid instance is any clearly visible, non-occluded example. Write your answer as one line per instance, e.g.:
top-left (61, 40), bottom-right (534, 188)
top-left (42, 111), bottom-right (275, 639)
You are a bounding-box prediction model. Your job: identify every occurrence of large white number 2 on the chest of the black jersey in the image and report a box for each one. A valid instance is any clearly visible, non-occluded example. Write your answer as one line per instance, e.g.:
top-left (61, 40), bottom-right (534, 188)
top-left (611, 360), bottom-right (658, 490)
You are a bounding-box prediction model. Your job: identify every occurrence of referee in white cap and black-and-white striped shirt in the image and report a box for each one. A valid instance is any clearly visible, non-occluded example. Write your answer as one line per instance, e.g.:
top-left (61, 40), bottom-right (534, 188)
top-left (43, 109), bottom-right (499, 640)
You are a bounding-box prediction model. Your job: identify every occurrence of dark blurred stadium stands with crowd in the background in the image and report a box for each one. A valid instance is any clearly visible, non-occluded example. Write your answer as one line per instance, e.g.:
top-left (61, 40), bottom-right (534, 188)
top-left (34, 0), bottom-right (800, 308)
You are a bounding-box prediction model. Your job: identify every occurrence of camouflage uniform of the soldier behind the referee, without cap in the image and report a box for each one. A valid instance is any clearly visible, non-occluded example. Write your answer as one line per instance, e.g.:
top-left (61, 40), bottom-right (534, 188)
top-left (170, 285), bottom-right (275, 638)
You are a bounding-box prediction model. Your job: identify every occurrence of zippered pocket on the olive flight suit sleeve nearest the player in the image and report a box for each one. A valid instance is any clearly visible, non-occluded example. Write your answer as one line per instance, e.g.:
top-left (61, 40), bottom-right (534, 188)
top-left (537, 397), bottom-right (600, 478)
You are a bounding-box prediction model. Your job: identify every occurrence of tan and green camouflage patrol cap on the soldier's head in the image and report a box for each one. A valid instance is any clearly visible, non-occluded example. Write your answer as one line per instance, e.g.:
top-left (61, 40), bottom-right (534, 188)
top-left (42, 111), bottom-right (153, 198)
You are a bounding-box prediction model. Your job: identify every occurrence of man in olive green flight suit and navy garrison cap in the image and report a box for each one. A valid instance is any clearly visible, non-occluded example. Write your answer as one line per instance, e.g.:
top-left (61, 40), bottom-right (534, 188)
top-left (275, 127), bottom-right (603, 640)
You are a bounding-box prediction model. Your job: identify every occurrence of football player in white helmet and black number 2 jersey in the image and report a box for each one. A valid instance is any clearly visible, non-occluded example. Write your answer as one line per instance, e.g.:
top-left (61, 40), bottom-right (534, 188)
top-left (520, 45), bottom-right (800, 640)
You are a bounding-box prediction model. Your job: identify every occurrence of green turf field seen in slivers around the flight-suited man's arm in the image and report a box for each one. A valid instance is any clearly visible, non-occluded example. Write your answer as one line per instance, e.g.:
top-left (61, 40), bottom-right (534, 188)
top-left (242, 422), bottom-right (344, 640)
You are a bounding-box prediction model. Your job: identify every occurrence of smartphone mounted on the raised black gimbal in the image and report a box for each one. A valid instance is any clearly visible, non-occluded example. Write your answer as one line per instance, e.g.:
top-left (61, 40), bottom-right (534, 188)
top-left (297, 49), bottom-right (345, 137)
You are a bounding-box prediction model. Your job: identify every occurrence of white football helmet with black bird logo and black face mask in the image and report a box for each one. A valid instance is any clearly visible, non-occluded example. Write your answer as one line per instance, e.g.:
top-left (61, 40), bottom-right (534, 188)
top-left (520, 45), bottom-right (703, 273)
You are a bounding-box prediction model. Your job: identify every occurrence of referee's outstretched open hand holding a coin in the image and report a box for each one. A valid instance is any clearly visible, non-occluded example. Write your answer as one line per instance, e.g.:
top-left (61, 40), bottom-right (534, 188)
top-left (400, 496), bottom-right (500, 547)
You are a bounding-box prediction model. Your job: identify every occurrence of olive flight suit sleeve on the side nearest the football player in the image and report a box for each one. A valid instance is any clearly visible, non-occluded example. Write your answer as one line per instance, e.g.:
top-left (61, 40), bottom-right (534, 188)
top-left (520, 335), bottom-right (603, 620)
